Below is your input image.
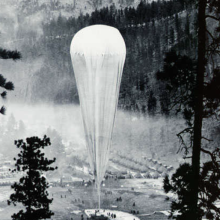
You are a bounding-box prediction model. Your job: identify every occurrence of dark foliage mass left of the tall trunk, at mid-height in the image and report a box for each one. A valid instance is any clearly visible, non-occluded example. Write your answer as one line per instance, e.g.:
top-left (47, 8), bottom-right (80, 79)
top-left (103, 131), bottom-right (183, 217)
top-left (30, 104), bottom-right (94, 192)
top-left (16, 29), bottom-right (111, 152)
top-left (156, 51), bottom-right (196, 126)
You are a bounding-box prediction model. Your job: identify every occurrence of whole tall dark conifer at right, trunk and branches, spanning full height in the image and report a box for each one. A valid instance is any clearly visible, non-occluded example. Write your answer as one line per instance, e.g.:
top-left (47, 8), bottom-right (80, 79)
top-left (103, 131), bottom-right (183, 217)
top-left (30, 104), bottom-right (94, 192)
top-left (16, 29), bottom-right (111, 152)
top-left (158, 0), bottom-right (220, 217)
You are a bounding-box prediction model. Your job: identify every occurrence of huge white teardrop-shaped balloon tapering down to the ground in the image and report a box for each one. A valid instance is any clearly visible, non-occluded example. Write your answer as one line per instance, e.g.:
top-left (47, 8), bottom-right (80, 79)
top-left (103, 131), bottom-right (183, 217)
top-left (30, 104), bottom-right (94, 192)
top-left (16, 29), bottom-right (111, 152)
top-left (70, 25), bottom-right (126, 207)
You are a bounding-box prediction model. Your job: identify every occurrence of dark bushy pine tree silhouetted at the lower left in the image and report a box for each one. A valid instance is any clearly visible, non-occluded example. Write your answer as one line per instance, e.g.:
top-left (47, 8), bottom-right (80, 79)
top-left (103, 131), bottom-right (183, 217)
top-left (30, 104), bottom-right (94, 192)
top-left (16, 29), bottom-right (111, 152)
top-left (8, 136), bottom-right (57, 220)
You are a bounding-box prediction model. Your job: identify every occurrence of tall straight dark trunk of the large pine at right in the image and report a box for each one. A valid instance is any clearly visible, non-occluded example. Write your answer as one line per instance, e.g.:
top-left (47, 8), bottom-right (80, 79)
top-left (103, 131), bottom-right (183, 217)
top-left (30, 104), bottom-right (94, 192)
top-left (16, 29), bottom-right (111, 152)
top-left (191, 0), bottom-right (207, 220)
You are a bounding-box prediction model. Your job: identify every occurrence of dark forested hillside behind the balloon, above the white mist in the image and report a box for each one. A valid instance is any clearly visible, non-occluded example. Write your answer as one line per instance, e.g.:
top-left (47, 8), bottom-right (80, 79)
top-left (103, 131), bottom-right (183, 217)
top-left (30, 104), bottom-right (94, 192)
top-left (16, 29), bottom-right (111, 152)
top-left (4, 0), bottom-right (197, 117)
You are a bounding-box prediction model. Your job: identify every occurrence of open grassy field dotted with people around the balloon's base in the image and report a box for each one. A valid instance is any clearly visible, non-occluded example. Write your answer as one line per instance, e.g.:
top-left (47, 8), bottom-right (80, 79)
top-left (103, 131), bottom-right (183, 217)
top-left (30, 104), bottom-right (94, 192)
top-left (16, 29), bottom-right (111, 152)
top-left (0, 179), bottom-right (170, 220)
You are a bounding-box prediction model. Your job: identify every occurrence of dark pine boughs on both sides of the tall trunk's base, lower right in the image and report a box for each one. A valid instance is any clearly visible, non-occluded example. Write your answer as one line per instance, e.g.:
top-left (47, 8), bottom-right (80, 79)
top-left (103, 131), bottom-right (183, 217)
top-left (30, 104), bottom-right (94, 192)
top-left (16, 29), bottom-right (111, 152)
top-left (164, 154), bottom-right (220, 220)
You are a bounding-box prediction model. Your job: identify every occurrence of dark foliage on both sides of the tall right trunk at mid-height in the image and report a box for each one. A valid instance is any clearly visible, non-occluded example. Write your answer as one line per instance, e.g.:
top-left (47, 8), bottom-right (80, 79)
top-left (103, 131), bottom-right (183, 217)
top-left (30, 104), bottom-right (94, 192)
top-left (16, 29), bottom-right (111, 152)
top-left (156, 51), bottom-right (220, 132)
